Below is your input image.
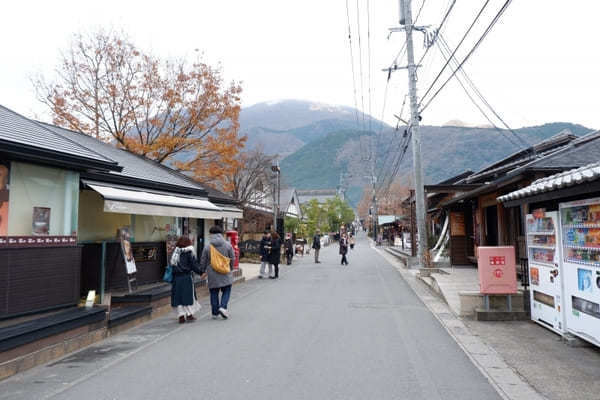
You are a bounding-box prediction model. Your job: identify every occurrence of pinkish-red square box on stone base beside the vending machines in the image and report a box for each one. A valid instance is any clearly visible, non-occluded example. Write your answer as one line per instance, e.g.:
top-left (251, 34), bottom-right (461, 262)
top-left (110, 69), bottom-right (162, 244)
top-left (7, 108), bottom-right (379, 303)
top-left (477, 246), bottom-right (517, 294)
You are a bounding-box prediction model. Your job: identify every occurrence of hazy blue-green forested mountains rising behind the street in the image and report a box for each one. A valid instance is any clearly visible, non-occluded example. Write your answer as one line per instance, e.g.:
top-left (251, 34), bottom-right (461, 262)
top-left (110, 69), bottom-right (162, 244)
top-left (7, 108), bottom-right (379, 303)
top-left (240, 100), bottom-right (591, 206)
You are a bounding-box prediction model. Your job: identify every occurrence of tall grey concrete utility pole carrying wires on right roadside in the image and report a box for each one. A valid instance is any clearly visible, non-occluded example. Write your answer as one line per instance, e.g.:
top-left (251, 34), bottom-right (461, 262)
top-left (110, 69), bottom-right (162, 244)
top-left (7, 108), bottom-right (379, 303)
top-left (399, 0), bottom-right (428, 268)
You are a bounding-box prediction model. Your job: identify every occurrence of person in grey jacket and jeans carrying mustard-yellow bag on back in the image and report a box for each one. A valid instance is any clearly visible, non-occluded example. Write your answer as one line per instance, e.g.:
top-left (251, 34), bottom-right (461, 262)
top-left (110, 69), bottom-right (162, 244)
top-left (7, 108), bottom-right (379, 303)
top-left (200, 225), bottom-right (235, 319)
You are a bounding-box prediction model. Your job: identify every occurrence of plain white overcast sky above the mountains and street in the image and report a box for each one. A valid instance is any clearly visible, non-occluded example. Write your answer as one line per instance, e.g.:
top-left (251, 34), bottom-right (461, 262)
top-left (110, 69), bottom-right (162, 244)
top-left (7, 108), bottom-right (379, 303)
top-left (0, 0), bottom-right (600, 128)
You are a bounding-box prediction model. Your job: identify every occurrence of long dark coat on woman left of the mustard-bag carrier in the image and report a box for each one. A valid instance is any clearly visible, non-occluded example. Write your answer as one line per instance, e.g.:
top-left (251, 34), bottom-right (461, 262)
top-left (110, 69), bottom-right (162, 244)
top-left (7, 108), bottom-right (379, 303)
top-left (171, 246), bottom-right (202, 307)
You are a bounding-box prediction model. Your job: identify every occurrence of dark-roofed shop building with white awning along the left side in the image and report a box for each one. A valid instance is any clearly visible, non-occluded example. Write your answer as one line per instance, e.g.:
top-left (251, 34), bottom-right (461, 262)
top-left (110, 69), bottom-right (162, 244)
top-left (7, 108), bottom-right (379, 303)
top-left (0, 107), bottom-right (242, 319)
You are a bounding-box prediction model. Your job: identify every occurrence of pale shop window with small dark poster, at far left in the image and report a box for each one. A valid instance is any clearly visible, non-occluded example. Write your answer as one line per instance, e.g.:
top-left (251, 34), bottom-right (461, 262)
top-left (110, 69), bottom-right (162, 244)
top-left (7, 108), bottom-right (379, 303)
top-left (7, 162), bottom-right (79, 236)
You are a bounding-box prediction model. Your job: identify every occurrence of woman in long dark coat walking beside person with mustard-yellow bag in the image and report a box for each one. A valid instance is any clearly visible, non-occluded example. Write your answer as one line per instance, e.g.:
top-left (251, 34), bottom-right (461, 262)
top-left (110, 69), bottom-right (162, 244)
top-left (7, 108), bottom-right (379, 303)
top-left (170, 236), bottom-right (203, 324)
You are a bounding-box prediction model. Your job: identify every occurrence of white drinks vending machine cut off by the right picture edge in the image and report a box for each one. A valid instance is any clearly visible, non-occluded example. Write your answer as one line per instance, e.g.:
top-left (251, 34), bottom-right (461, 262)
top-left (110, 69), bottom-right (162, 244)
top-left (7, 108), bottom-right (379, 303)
top-left (560, 198), bottom-right (600, 346)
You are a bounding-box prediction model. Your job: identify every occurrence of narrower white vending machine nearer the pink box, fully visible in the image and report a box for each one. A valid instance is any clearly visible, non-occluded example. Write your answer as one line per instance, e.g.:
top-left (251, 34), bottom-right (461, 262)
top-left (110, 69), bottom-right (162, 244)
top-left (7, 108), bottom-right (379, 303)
top-left (526, 210), bottom-right (564, 334)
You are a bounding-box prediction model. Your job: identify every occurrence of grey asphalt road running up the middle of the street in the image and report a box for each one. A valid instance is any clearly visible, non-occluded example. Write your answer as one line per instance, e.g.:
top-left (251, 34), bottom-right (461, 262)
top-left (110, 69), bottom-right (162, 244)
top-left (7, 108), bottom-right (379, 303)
top-left (0, 234), bottom-right (500, 400)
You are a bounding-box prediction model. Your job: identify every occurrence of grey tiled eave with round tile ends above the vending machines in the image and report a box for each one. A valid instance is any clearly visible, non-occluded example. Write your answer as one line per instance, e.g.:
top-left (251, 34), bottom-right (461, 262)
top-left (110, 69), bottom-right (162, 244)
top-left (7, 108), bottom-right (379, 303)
top-left (498, 162), bottom-right (600, 203)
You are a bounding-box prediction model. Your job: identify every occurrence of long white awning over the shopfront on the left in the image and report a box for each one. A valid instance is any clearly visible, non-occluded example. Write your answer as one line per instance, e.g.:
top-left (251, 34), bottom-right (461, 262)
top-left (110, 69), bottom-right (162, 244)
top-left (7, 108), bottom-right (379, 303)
top-left (86, 182), bottom-right (226, 219)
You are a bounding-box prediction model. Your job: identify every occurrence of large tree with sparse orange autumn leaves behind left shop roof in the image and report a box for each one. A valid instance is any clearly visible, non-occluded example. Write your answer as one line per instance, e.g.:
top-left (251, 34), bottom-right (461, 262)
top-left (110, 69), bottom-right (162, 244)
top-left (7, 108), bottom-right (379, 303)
top-left (33, 30), bottom-right (246, 189)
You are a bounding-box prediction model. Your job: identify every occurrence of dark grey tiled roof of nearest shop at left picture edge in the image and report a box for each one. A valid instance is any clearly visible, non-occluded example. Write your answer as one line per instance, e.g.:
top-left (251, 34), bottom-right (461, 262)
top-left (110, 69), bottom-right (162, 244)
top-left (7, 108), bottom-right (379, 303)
top-left (0, 106), bottom-right (116, 165)
